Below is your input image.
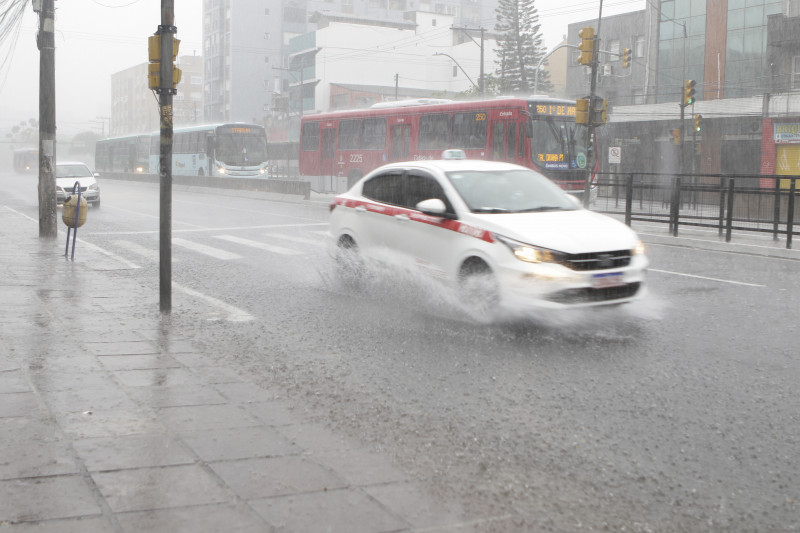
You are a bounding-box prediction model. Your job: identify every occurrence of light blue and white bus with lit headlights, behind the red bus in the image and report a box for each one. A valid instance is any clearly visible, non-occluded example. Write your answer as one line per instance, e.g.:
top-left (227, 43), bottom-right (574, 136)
top-left (145, 122), bottom-right (269, 178)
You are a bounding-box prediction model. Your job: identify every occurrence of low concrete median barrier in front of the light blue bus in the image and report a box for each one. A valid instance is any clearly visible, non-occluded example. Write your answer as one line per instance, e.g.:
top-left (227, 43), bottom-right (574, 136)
top-left (102, 172), bottom-right (311, 200)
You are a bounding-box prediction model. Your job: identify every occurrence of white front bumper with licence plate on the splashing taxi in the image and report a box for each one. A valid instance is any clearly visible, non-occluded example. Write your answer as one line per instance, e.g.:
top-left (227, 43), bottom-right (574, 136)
top-left (499, 256), bottom-right (648, 309)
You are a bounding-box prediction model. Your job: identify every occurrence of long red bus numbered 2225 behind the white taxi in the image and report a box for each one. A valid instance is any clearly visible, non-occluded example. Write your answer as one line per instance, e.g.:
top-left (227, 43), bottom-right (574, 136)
top-left (299, 96), bottom-right (594, 196)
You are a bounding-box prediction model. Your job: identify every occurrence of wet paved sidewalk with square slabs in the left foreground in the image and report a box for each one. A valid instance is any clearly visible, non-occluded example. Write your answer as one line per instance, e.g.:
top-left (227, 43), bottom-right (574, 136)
top-left (0, 205), bottom-right (517, 533)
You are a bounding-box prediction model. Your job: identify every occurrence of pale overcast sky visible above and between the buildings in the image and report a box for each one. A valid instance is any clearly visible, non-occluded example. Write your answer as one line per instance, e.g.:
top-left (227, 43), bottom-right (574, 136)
top-left (0, 0), bottom-right (645, 137)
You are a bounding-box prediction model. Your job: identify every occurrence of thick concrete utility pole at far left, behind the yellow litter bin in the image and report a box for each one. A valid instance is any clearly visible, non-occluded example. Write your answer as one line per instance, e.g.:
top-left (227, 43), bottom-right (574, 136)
top-left (34, 0), bottom-right (58, 239)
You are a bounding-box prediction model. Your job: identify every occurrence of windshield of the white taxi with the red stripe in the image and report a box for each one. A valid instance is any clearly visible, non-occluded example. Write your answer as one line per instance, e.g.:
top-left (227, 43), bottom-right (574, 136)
top-left (447, 169), bottom-right (577, 213)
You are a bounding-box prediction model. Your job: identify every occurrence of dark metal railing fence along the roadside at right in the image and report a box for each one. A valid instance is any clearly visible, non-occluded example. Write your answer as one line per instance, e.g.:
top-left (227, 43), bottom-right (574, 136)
top-left (593, 173), bottom-right (800, 248)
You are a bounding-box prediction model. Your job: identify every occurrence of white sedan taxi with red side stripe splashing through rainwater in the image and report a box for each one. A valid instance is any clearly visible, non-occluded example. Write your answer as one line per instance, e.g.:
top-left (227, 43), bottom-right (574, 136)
top-left (330, 154), bottom-right (648, 310)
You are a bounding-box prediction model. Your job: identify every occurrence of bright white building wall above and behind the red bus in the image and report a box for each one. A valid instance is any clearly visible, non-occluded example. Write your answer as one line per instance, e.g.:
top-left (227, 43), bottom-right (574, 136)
top-left (315, 12), bottom-right (495, 112)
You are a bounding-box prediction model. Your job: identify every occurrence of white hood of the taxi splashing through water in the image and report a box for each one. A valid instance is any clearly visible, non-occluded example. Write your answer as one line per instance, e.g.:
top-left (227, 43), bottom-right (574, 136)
top-left (472, 209), bottom-right (639, 254)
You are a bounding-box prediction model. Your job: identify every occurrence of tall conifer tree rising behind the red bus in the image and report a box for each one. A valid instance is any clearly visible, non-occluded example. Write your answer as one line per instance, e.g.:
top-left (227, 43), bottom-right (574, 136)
top-left (494, 0), bottom-right (552, 93)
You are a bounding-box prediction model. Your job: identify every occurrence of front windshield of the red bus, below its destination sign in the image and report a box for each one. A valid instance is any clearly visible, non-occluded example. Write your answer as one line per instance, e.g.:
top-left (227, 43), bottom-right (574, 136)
top-left (531, 116), bottom-right (588, 170)
